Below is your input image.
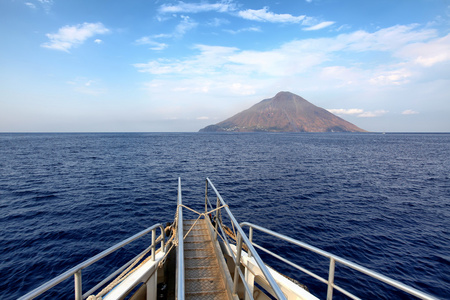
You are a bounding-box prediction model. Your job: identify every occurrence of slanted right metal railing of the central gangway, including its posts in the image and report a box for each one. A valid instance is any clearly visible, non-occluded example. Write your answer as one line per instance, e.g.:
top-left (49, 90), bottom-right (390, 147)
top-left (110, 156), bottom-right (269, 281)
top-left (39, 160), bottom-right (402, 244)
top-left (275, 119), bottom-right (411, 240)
top-left (205, 178), bottom-right (286, 299)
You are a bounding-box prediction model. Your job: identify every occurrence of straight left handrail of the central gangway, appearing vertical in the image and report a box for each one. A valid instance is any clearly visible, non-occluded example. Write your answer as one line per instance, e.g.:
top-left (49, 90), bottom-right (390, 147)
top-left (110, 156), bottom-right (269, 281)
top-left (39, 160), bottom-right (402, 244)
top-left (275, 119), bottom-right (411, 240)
top-left (176, 178), bottom-right (184, 300)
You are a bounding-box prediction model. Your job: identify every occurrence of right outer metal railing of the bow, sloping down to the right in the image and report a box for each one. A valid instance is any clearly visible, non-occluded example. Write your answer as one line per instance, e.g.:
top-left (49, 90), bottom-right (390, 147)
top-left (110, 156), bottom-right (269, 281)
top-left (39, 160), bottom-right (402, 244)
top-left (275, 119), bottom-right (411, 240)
top-left (240, 222), bottom-right (438, 300)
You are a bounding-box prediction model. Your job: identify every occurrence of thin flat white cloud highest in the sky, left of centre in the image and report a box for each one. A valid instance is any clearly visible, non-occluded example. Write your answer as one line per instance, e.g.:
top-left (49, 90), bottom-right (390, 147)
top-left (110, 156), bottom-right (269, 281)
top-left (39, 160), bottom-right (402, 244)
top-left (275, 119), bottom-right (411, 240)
top-left (159, 1), bottom-right (235, 14)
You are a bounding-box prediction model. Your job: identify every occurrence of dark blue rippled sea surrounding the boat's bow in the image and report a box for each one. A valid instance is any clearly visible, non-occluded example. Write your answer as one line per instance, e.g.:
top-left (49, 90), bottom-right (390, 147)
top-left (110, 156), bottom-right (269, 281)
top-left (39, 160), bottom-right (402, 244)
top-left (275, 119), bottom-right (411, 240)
top-left (0, 133), bottom-right (450, 299)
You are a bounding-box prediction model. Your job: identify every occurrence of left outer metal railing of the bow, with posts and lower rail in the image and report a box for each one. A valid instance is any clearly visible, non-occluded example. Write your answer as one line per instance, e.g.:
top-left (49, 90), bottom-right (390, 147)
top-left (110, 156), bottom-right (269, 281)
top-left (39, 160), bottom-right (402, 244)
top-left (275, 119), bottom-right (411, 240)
top-left (19, 223), bottom-right (166, 300)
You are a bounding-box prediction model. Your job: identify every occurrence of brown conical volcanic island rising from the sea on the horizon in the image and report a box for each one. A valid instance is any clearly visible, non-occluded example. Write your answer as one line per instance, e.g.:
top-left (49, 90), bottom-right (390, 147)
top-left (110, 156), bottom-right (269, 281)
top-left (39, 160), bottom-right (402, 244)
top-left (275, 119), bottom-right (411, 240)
top-left (200, 92), bottom-right (365, 132)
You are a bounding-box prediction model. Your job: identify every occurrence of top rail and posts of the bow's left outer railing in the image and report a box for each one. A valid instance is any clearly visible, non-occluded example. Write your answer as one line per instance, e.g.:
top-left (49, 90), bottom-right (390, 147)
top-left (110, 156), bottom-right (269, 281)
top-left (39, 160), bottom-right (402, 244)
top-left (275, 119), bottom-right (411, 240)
top-left (19, 223), bottom-right (166, 300)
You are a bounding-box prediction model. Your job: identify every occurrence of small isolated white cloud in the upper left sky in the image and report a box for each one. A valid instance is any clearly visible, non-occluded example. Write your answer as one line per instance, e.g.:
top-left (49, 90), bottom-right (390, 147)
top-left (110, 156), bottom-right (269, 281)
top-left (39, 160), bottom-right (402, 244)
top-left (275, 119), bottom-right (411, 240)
top-left (41, 23), bottom-right (109, 52)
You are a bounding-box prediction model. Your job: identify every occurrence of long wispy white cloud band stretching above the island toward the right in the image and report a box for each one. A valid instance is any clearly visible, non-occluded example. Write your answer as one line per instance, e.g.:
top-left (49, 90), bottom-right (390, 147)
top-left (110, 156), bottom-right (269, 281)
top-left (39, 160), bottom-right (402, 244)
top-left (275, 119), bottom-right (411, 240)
top-left (135, 26), bottom-right (450, 77)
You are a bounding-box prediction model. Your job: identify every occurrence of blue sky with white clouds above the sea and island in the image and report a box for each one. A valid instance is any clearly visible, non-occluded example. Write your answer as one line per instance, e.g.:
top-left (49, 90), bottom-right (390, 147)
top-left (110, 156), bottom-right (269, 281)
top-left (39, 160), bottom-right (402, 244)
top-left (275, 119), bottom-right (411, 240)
top-left (0, 0), bottom-right (450, 132)
